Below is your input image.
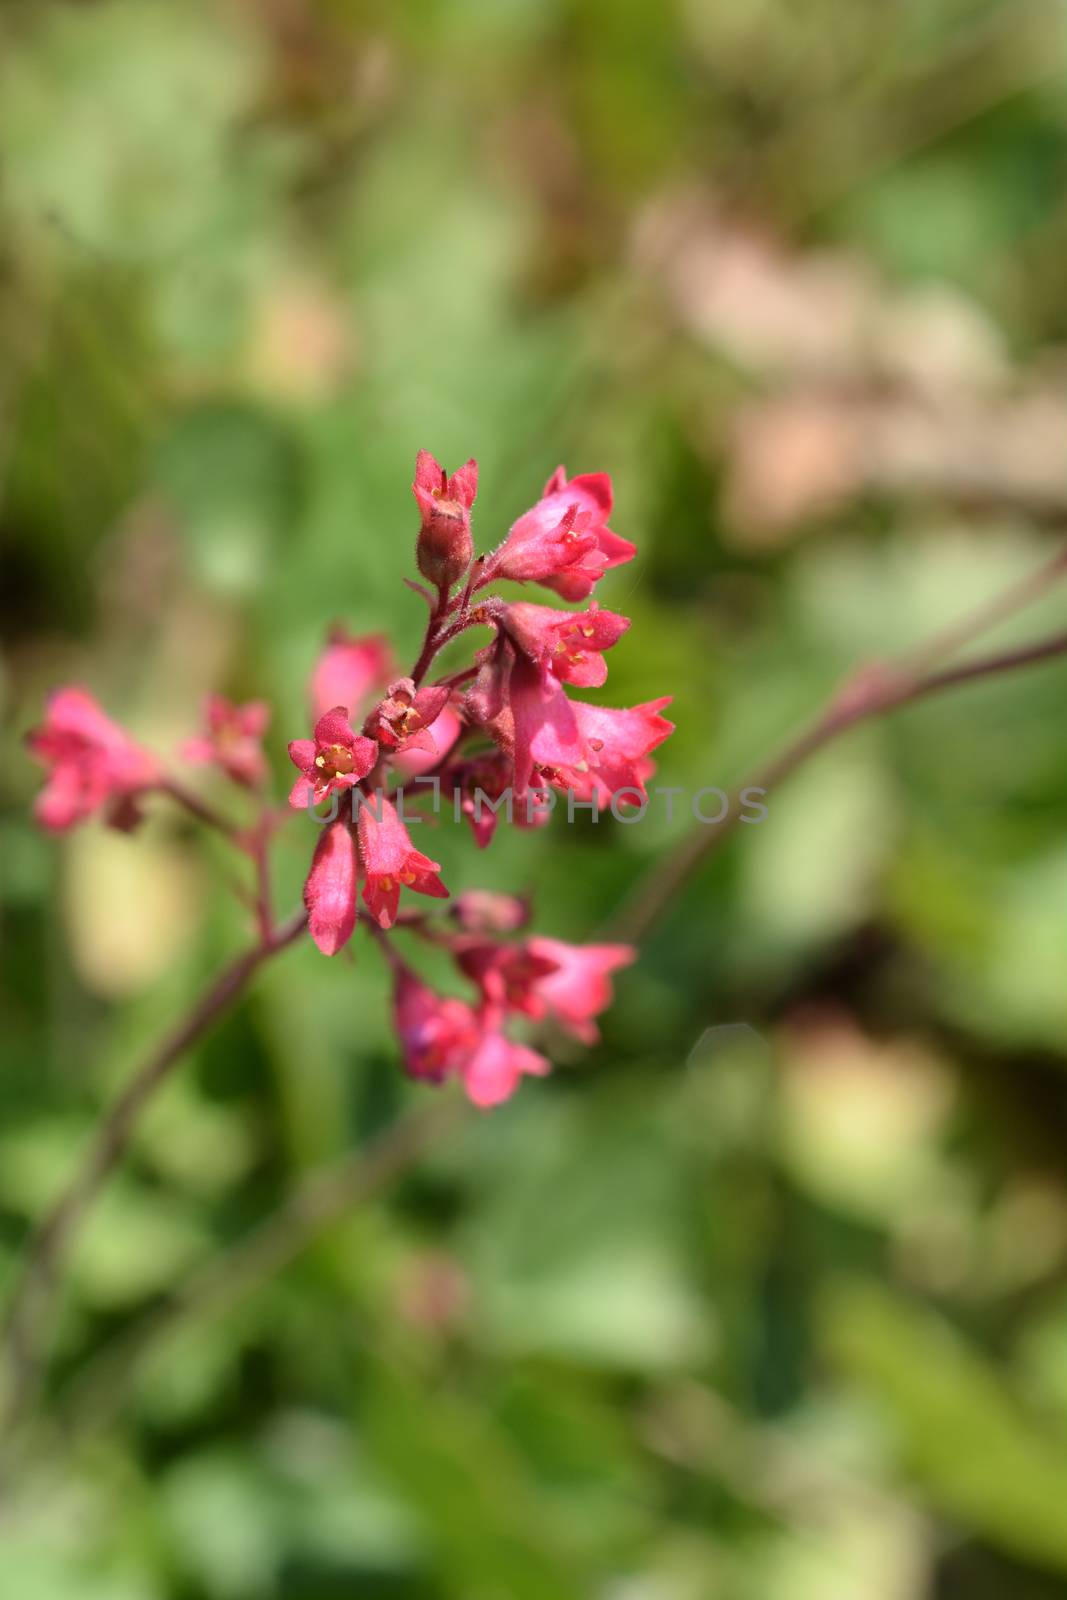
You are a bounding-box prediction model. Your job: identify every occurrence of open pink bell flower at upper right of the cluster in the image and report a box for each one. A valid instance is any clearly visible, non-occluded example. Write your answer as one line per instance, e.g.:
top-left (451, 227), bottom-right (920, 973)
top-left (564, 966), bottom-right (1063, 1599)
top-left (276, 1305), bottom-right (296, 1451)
top-left (485, 467), bottom-right (635, 600)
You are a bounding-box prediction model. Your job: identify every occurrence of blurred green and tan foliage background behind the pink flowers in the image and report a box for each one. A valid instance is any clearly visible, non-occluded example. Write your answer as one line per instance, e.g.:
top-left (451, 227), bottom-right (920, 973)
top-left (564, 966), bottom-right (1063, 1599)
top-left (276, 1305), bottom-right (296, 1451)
top-left (0, 0), bottom-right (1067, 1600)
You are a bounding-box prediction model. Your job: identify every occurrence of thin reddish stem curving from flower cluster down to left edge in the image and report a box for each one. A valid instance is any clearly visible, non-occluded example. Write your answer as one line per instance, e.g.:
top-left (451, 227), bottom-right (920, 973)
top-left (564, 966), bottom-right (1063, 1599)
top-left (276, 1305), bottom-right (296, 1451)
top-left (0, 912), bottom-right (307, 1424)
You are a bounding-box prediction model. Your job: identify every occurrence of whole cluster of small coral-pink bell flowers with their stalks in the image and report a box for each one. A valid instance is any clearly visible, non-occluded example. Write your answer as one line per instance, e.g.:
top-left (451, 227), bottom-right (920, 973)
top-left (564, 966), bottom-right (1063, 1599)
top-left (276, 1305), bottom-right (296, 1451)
top-left (29, 451), bottom-right (672, 1106)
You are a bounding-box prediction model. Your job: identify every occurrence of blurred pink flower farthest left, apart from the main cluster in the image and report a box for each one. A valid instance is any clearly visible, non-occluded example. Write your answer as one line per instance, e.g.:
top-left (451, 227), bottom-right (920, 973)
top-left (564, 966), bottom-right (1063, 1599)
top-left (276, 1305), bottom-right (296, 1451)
top-left (26, 688), bottom-right (162, 834)
